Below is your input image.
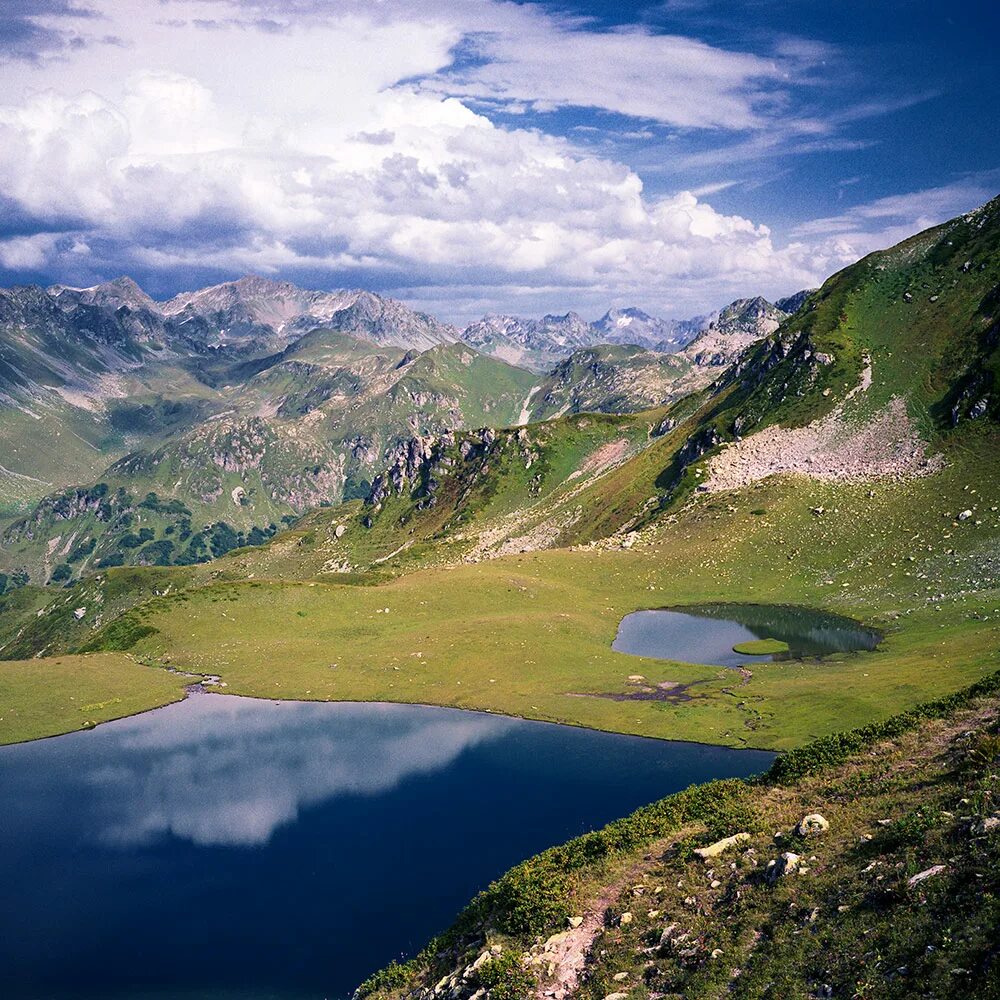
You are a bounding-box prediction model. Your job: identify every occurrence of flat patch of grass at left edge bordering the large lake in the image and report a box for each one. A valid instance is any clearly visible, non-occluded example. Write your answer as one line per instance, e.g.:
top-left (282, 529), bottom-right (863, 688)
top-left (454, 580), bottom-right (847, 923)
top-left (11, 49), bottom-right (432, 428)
top-left (0, 653), bottom-right (191, 745)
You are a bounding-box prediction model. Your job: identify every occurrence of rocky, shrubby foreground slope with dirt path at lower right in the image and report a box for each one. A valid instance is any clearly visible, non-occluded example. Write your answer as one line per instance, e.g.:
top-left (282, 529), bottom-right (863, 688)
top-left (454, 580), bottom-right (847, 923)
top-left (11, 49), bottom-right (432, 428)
top-left (360, 675), bottom-right (1000, 1000)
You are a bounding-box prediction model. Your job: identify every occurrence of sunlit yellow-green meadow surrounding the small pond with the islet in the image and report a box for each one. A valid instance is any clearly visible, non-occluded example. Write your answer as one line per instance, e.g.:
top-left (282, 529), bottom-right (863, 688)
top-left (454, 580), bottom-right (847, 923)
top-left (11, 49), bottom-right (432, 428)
top-left (56, 430), bottom-right (1000, 749)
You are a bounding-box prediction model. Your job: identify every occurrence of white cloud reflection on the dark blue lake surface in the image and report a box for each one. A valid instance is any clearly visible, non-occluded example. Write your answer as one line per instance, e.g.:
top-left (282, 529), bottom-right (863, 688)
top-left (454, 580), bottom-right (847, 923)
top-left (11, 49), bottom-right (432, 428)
top-left (82, 696), bottom-right (515, 847)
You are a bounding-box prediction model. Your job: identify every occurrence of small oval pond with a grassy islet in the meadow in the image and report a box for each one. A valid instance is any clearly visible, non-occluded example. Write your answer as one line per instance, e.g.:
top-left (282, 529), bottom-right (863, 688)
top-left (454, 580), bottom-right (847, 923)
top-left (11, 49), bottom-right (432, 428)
top-left (613, 604), bottom-right (882, 667)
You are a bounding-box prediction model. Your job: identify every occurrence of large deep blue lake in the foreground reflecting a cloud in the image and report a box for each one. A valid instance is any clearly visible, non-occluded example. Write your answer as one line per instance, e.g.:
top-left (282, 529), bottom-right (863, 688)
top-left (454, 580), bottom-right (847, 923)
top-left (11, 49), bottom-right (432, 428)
top-left (0, 694), bottom-right (773, 1000)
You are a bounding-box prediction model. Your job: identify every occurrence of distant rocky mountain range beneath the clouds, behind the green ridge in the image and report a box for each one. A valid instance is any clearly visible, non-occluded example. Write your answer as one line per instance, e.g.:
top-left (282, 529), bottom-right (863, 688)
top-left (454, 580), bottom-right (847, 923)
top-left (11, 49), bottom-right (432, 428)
top-left (0, 277), bottom-right (800, 582)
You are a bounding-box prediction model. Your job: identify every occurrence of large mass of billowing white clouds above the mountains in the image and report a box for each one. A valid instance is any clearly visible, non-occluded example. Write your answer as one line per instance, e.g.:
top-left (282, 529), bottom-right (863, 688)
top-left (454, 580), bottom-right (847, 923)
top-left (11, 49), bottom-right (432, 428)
top-left (0, 0), bottom-right (984, 318)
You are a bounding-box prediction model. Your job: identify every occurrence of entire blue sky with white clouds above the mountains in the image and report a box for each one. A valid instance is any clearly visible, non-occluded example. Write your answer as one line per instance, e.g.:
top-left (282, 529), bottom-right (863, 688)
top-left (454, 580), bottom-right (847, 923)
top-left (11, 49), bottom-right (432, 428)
top-left (0, 0), bottom-right (1000, 323)
